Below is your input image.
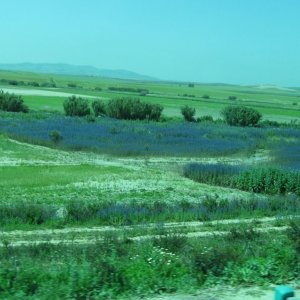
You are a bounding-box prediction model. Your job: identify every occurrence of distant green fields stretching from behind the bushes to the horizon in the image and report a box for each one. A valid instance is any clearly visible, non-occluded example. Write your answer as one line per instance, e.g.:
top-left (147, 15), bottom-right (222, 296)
top-left (0, 71), bottom-right (300, 122)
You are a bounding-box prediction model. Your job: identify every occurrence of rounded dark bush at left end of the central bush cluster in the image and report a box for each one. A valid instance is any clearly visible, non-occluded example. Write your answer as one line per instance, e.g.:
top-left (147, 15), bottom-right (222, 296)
top-left (63, 96), bottom-right (91, 117)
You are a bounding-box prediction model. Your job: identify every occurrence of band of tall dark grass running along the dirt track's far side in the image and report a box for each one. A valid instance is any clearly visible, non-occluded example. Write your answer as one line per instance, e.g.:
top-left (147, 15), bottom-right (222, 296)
top-left (0, 196), bottom-right (300, 228)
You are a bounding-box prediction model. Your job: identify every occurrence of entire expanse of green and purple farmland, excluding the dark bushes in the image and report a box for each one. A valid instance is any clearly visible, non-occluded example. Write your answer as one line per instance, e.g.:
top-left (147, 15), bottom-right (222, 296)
top-left (0, 71), bottom-right (300, 299)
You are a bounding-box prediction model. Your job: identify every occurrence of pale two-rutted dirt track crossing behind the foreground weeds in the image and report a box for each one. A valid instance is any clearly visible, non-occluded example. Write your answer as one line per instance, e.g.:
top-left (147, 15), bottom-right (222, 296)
top-left (0, 216), bottom-right (299, 247)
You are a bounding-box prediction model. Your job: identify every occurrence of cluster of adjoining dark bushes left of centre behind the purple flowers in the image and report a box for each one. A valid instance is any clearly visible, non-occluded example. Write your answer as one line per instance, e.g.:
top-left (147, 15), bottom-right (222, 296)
top-left (63, 96), bottom-right (163, 121)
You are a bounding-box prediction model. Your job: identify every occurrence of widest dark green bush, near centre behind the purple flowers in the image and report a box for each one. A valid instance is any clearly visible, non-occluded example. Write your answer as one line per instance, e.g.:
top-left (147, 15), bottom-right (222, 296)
top-left (106, 98), bottom-right (163, 121)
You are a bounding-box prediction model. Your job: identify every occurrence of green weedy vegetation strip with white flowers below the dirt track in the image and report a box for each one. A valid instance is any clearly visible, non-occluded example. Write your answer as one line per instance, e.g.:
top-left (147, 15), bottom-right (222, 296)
top-left (0, 221), bottom-right (300, 299)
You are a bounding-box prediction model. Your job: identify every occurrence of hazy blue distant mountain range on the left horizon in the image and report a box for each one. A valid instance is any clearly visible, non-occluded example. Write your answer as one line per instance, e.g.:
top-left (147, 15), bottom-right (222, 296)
top-left (0, 63), bottom-right (158, 81)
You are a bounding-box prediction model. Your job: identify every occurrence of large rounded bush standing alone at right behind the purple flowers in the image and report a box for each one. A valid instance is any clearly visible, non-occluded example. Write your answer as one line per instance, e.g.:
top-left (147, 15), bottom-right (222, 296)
top-left (221, 106), bottom-right (262, 127)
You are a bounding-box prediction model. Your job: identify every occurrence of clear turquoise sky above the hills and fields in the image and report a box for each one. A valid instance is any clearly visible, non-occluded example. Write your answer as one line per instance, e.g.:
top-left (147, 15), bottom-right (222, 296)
top-left (0, 0), bottom-right (300, 86)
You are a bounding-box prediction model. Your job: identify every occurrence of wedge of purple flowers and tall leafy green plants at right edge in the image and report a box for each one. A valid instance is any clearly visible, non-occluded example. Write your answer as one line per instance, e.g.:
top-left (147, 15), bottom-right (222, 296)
top-left (183, 163), bottom-right (300, 195)
